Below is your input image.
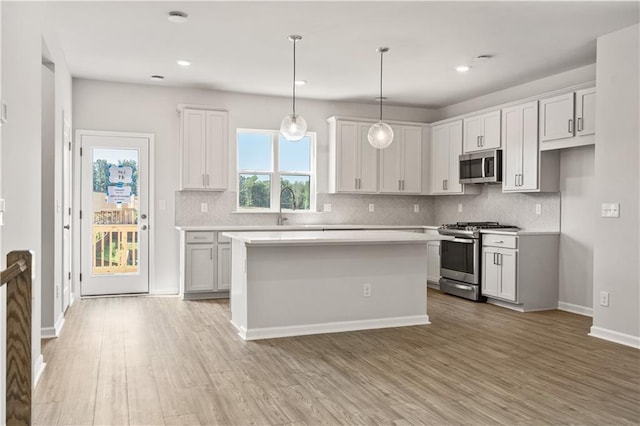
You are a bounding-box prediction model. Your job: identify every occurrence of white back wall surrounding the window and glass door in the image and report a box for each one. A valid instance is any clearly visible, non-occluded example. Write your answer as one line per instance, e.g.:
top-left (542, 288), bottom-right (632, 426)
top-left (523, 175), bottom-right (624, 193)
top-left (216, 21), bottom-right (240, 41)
top-left (73, 79), bottom-right (436, 293)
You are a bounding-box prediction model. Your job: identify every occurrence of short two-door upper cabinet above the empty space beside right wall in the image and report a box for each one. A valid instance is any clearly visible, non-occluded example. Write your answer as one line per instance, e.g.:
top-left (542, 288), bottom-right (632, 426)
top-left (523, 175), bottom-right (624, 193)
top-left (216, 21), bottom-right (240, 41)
top-left (540, 87), bottom-right (596, 151)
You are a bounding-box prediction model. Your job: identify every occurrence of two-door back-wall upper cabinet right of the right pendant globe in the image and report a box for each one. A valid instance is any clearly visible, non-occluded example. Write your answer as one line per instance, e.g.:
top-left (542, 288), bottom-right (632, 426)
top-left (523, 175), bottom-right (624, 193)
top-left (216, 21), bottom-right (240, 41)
top-left (379, 126), bottom-right (422, 194)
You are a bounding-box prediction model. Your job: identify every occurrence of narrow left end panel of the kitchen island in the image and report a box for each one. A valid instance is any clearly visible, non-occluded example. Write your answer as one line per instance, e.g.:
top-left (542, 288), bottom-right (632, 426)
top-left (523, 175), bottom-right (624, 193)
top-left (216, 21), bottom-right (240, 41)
top-left (229, 239), bottom-right (247, 332)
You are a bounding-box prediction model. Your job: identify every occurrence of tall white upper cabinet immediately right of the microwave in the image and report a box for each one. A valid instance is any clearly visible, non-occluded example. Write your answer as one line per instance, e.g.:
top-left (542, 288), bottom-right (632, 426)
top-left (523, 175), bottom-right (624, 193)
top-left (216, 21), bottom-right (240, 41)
top-left (502, 101), bottom-right (559, 192)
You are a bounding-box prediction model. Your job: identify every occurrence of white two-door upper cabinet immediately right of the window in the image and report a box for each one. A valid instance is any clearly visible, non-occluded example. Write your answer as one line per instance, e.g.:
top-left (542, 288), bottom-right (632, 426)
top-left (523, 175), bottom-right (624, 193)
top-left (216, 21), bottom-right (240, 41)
top-left (329, 118), bottom-right (378, 193)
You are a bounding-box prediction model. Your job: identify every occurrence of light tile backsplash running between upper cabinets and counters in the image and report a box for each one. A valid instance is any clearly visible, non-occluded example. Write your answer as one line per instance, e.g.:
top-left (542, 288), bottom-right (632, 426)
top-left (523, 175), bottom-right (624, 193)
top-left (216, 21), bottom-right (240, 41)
top-left (175, 185), bottom-right (560, 231)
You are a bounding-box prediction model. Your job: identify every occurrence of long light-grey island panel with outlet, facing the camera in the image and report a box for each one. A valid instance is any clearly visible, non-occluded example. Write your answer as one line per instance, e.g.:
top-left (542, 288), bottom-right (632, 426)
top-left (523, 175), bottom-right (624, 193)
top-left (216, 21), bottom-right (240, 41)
top-left (242, 243), bottom-right (428, 335)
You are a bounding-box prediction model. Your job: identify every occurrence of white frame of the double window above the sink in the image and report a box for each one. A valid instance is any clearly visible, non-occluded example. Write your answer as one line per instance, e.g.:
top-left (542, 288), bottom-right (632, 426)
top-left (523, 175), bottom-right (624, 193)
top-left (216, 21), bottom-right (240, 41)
top-left (236, 128), bottom-right (317, 213)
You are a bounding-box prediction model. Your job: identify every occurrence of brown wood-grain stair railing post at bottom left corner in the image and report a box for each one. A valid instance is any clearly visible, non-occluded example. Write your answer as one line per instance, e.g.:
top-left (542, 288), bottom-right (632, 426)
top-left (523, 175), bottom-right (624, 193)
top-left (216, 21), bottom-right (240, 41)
top-left (0, 251), bottom-right (32, 426)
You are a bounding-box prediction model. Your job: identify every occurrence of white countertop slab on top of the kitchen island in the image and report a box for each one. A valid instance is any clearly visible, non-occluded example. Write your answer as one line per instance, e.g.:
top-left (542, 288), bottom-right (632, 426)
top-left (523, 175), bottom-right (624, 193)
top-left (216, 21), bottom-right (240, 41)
top-left (222, 230), bottom-right (453, 245)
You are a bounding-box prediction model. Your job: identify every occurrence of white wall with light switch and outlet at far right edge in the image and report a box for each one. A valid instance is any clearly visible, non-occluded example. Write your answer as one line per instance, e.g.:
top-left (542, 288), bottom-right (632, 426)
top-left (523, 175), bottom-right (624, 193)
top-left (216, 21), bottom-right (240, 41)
top-left (591, 25), bottom-right (640, 348)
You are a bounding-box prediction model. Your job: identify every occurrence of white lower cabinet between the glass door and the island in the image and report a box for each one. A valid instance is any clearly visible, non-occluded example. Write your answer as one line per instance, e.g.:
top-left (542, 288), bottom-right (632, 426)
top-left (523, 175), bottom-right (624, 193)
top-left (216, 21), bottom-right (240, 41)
top-left (180, 231), bottom-right (231, 299)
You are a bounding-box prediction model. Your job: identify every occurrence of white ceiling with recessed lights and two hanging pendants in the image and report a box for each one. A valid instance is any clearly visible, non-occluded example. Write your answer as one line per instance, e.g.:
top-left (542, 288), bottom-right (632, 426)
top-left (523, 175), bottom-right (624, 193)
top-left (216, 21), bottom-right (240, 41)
top-left (51, 1), bottom-right (639, 107)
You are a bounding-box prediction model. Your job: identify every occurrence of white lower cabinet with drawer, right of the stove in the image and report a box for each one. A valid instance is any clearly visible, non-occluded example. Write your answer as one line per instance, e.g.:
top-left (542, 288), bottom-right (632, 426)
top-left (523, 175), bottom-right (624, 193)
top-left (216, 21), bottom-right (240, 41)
top-left (481, 233), bottom-right (560, 311)
